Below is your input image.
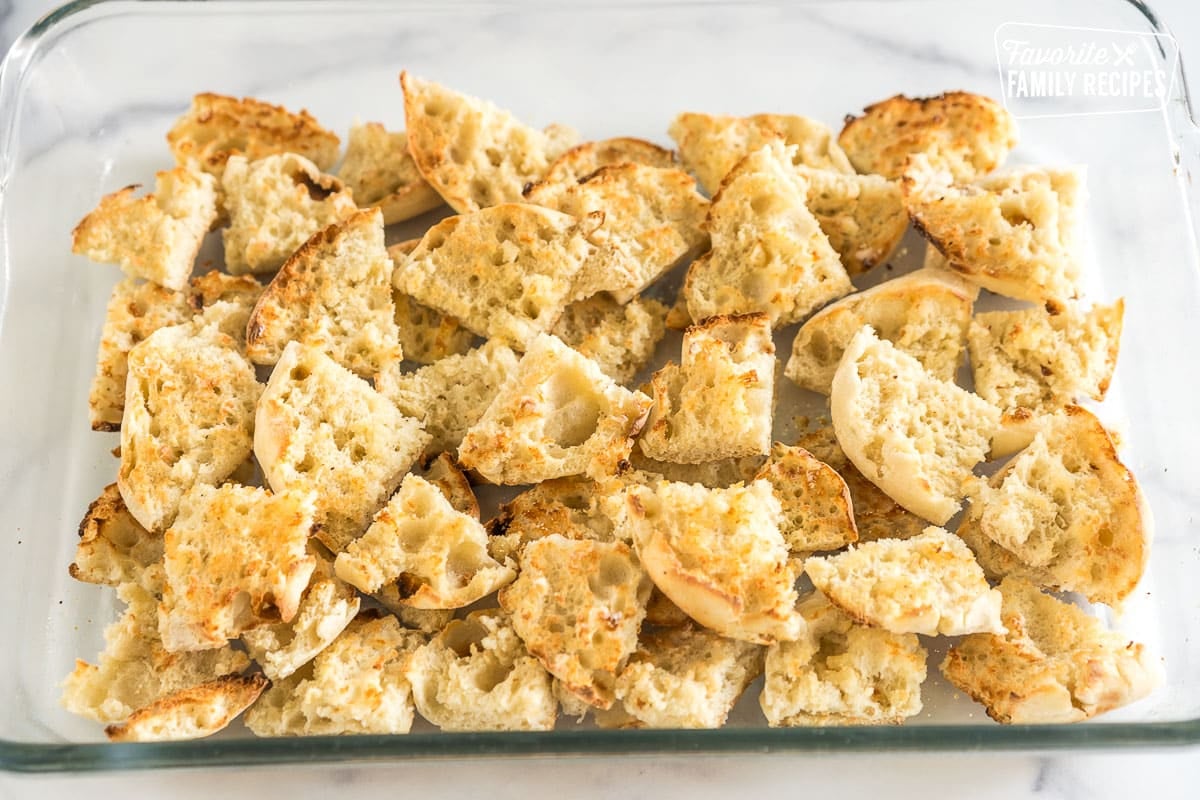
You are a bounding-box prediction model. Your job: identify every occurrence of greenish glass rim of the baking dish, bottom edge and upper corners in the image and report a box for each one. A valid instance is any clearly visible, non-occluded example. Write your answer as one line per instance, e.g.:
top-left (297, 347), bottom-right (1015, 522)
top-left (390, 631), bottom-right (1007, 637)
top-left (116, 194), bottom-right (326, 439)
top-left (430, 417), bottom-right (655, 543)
top-left (0, 0), bottom-right (1200, 772)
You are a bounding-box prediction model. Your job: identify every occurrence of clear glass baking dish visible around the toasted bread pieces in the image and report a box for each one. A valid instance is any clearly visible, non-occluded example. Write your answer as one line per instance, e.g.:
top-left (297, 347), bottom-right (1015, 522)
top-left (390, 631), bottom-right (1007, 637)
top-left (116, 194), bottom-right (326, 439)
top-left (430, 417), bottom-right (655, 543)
top-left (0, 0), bottom-right (1200, 770)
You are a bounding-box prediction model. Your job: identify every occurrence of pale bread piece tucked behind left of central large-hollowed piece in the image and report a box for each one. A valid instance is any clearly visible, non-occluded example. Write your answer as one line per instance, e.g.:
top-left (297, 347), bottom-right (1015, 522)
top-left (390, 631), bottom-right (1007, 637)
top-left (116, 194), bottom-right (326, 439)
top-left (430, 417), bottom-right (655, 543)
top-left (376, 339), bottom-right (520, 452)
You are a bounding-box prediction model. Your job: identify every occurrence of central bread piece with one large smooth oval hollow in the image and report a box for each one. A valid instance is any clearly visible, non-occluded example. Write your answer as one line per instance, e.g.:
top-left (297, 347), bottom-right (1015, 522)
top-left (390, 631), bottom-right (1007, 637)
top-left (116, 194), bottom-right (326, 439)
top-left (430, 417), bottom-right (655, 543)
top-left (458, 333), bottom-right (650, 485)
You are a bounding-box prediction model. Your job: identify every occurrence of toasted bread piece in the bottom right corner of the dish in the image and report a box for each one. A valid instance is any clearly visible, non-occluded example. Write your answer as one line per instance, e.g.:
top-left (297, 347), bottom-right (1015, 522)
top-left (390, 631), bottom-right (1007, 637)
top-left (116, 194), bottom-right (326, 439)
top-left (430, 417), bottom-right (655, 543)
top-left (941, 577), bottom-right (1163, 724)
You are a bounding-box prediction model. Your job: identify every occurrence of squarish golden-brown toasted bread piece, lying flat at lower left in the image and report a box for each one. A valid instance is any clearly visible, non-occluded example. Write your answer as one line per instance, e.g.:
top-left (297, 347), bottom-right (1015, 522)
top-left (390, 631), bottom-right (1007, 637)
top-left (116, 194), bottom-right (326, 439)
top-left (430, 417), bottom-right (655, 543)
top-left (158, 485), bottom-right (317, 651)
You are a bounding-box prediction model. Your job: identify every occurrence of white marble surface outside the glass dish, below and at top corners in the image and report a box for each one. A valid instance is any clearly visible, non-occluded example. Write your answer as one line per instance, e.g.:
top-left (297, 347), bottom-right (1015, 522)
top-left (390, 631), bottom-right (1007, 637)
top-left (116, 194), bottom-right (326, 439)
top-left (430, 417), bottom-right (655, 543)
top-left (0, 0), bottom-right (1200, 800)
